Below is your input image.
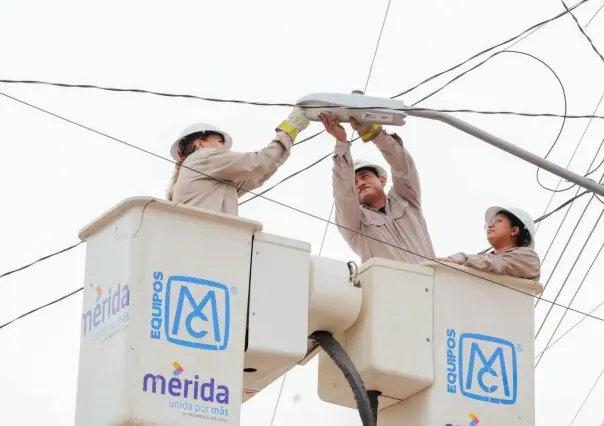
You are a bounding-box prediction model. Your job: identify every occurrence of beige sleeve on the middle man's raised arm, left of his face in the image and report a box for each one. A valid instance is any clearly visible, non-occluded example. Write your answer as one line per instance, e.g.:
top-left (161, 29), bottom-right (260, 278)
top-left (332, 142), bottom-right (361, 241)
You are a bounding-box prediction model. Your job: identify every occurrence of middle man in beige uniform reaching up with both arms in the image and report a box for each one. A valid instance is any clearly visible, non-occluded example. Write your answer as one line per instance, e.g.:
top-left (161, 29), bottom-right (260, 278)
top-left (321, 114), bottom-right (434, 263)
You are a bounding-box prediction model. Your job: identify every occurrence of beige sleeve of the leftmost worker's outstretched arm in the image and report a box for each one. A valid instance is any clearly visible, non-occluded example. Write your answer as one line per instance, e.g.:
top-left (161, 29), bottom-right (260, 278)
top-left (188, 139), bottom-right (291, 185)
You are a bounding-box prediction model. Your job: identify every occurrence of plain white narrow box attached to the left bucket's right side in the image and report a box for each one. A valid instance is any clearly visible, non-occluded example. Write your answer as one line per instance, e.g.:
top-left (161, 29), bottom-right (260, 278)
top-left (244, 232), bottom-right (311, 391)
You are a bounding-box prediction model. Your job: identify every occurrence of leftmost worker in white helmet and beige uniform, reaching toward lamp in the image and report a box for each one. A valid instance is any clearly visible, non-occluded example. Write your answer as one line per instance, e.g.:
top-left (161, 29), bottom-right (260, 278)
top-left (166, 108), bottom-right (309, 215)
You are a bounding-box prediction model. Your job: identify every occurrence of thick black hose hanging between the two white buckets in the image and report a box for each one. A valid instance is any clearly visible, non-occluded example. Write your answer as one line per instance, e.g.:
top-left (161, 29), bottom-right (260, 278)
top-left (310, 330), bottom-right (377, 426)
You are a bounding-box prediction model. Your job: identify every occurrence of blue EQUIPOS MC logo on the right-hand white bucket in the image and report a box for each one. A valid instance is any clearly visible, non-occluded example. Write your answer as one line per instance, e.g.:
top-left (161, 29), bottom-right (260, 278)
top-left (447, 329), bottom-right (518, 405)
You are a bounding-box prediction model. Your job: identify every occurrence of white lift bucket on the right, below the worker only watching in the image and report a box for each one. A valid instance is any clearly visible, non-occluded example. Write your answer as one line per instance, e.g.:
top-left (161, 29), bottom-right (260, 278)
top-left (378, 263), bottom-right (542, 426)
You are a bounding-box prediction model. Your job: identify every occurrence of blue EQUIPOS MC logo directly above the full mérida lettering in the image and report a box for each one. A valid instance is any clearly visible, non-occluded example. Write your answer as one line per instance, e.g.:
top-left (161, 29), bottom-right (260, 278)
top-left (151, 272), bottom-right (230, 351)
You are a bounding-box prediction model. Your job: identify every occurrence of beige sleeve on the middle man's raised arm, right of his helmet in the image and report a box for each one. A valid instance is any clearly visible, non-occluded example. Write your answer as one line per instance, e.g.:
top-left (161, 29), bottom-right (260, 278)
top-left (373, 131), bottom-right (421, 209)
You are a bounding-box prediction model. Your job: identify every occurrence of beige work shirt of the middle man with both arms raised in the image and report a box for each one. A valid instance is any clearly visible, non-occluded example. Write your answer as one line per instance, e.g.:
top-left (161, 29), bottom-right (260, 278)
top-left (333, 132), bottom-right (434, 263)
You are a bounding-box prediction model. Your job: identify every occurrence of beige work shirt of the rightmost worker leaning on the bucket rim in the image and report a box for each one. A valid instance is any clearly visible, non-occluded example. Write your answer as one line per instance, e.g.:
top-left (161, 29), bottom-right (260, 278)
top-left (449, 247), bottom-right (541, 281)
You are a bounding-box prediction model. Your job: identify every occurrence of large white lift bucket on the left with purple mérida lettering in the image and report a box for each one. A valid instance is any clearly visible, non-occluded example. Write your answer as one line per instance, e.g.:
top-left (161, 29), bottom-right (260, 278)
top-left (75, 198), bottom-right (261, 426)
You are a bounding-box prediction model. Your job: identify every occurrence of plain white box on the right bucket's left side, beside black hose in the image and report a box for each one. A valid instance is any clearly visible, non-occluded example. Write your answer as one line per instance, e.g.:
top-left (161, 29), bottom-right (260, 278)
top-left (319, 258), bottom-right (434, 409)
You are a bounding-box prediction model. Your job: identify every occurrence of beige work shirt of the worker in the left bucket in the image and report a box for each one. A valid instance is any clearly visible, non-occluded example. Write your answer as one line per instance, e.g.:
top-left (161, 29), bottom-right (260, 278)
top-left (172, 136), bottom-right (291, 215)
